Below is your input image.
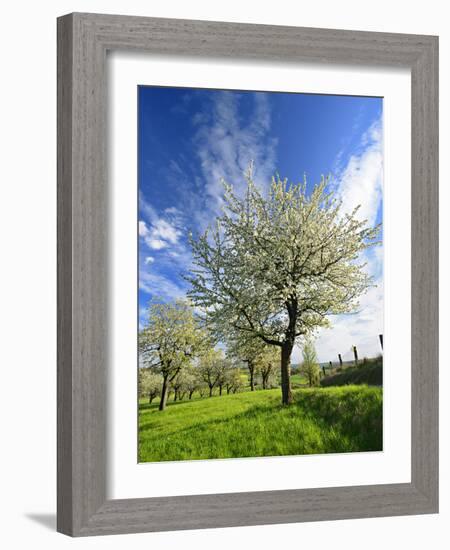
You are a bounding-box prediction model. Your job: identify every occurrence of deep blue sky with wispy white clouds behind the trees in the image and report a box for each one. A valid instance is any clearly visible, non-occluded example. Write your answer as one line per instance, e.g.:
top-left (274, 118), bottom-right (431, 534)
top-left (138, 86), bottom-right (383, 361)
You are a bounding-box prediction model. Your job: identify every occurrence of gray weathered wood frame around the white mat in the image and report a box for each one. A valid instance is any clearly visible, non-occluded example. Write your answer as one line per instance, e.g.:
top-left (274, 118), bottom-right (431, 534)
top-left (57, 13), bottom-right (438, 536)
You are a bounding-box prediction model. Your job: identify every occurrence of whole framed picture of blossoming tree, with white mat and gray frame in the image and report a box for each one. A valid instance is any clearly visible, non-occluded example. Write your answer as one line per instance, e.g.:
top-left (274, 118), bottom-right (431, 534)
top-left (57, 14), bottom-right (438, 536)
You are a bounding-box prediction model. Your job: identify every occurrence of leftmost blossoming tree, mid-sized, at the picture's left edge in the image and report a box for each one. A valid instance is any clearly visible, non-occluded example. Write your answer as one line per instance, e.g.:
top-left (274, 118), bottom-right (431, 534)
top-left (139, 300), bottom-right (208, 411)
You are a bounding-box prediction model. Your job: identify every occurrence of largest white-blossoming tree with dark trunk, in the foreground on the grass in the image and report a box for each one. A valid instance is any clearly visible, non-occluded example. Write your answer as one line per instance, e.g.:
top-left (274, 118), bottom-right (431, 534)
top-left (187, 168), bottom-right (379, 404)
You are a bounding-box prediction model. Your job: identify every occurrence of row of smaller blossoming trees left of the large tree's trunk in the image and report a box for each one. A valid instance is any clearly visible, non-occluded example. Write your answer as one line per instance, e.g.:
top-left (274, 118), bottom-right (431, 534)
top-left (139, 300), bottom-right (279, 410)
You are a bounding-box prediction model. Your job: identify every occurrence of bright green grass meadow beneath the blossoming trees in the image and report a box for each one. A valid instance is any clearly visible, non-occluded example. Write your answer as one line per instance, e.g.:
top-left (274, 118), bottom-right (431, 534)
top-left (139, 386), bottom-right (382, 462)
